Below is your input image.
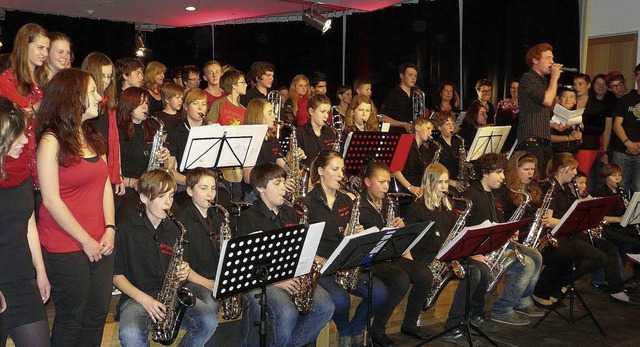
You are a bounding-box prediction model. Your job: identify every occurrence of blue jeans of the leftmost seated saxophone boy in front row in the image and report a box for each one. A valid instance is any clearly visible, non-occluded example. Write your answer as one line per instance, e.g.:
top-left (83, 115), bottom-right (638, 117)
top-left (119, 290), bottom-right (218, 347)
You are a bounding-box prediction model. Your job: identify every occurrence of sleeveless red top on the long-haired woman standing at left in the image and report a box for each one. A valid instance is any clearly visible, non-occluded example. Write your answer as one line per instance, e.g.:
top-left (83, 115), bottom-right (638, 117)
top-left (38, 157), bottom-right (108, 253)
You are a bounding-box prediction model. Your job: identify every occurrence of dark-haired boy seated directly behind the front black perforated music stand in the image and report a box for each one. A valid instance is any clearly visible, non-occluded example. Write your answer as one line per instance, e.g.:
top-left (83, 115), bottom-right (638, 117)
top-left (238, 163), bottom-right (334, 346)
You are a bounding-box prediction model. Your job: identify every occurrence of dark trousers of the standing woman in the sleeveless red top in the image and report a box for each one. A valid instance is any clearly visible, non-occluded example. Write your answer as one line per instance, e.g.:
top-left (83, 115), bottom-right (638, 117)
top-left (42, 249), bottom-right (114, 347)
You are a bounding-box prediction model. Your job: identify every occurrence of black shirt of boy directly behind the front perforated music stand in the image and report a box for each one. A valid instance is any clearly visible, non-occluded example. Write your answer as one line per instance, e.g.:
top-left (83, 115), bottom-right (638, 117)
top-left (237, 199), bottom-right (300, 236)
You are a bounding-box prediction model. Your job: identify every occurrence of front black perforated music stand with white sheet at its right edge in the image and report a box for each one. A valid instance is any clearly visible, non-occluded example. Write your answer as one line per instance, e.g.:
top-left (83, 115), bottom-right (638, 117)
top-left (213, 222), bottom-right (325, 347)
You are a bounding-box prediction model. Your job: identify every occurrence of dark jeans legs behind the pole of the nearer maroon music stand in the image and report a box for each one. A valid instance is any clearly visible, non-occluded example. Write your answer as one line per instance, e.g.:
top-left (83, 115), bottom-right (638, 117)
top-left (444, 259), bottom-right (490, 329)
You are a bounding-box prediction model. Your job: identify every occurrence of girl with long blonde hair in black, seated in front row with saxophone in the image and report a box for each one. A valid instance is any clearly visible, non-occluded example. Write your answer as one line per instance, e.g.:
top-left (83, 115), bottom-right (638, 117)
top-left (405, 164), bottom-right (486, 347)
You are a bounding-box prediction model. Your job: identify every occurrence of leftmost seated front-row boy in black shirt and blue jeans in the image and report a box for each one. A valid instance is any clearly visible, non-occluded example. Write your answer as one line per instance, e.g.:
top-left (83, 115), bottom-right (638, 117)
top-left (113, 170), bottom-right (218, 346)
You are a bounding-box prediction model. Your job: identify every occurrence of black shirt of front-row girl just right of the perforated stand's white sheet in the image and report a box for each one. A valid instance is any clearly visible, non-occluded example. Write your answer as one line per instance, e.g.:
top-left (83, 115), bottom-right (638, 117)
top-left (300, 184), bottom-right (354, 258)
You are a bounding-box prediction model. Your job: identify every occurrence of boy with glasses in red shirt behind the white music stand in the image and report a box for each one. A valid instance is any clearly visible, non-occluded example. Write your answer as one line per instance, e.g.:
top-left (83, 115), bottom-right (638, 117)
top-left (207, 69), bottom-right (247, 125)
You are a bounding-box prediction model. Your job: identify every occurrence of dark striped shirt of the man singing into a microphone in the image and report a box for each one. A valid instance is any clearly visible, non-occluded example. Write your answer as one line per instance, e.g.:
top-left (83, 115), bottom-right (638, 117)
top-left (518, 70), bottom-right (553, 143)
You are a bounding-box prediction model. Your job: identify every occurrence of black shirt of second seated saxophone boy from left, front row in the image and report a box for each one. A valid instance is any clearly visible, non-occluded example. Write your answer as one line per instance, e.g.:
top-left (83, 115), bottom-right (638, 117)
top-left (177, 201), bottom-right (223, 279)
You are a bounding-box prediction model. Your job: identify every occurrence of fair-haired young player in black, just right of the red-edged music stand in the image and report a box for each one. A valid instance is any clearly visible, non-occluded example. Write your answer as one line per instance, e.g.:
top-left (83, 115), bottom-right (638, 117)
top-left (392, 117), bottom-right (438, 196)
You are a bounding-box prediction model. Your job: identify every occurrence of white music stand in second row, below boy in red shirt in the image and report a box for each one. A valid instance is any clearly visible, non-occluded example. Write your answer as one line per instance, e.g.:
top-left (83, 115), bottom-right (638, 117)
top-left (180, 124), bottom-right (267, 171)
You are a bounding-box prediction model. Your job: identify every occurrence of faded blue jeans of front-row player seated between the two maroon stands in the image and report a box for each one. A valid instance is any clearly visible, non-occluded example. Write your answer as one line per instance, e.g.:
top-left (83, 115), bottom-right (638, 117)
top-left (491, 244), bottom-right (542, 315)
